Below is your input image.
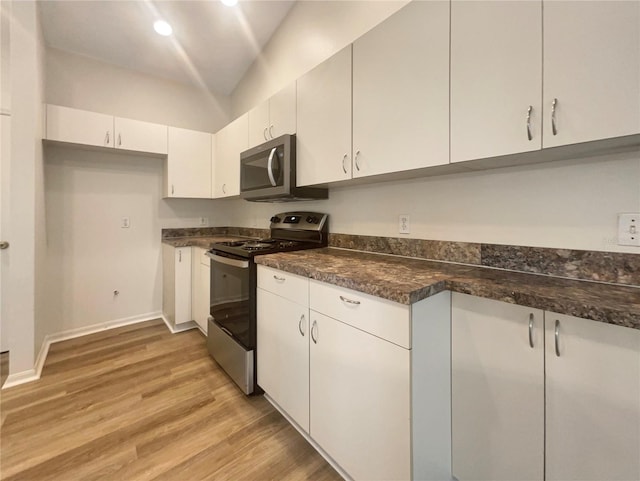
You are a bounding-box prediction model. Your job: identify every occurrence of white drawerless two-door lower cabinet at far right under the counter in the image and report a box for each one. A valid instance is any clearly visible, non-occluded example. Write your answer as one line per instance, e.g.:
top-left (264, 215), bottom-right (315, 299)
top-left (451, 293), bottom-right (640, 481)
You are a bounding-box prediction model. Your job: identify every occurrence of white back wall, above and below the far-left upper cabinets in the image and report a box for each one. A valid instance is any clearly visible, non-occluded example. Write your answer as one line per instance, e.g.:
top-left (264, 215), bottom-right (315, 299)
top-left (43, 49), bottom-right (238, 334)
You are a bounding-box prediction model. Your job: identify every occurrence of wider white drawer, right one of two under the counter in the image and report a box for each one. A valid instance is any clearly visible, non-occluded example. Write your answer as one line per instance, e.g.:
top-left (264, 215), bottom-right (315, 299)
top-left (309, 280), bottom-right (411, 349)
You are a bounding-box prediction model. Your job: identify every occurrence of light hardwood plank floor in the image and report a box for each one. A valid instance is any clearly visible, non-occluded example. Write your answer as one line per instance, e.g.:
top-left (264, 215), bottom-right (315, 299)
top-left (0, 320), bottom-right (341, 481)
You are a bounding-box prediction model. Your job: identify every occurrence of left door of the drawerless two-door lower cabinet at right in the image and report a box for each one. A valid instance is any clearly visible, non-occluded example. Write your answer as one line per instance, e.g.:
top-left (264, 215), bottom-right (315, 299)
top-left (451, 293), bottom-right (544, 481)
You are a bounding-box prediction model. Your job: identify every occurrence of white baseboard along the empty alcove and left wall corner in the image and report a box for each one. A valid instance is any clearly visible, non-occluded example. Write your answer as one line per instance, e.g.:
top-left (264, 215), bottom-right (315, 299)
top-left (2, 311), bottom-right (165, 389)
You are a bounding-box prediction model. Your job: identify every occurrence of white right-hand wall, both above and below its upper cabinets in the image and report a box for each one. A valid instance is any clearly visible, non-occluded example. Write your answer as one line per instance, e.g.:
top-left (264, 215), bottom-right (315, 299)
top-left (232, 1), bottom-right (640, 253)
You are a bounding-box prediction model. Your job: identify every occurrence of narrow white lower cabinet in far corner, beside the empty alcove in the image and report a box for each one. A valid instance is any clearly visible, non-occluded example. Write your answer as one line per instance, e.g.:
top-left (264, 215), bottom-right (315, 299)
top-left (162, 244), bottom-right (192, 326)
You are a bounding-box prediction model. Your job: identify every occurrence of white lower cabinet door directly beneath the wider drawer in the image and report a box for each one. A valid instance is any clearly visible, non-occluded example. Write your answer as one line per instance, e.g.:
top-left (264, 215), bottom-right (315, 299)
top-left (310, 311), bottom-right (411, 480)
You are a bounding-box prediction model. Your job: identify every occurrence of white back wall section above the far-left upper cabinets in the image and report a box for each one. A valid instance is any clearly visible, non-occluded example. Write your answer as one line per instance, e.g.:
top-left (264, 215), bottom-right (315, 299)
top-left (46, 48), bottom-right (230, 132)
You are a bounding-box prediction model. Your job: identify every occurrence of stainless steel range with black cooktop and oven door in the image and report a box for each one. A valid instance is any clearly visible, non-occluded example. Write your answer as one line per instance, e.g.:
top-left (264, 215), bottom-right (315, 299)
top-left (207, 212), bottom-right (328, 394)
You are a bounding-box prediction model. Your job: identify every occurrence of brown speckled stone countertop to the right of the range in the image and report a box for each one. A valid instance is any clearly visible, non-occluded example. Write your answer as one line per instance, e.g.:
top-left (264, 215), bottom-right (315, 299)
top-left (255, 248), bottom-right (640, 329)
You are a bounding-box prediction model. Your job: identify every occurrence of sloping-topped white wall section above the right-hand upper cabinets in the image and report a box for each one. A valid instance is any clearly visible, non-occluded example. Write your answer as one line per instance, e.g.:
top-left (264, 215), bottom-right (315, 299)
top-left (232, 0), bottom-right (408, 117)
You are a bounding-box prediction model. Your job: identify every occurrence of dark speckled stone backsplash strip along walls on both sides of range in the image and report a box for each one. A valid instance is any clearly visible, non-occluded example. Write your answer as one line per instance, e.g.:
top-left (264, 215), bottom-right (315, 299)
top-left (162, 227), bottom-right (640, 286)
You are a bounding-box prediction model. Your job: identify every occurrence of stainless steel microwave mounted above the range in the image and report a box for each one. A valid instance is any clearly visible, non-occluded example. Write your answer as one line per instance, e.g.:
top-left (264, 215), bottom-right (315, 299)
top-left (240, 134), bottom-right (329, 202)
